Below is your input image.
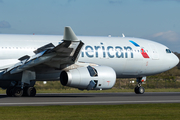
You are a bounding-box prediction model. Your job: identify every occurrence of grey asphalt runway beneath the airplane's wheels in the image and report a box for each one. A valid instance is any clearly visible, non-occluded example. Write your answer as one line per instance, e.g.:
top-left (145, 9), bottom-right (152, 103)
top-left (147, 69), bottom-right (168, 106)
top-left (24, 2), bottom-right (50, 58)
top-left (0, 92), bottom-right (180, 106)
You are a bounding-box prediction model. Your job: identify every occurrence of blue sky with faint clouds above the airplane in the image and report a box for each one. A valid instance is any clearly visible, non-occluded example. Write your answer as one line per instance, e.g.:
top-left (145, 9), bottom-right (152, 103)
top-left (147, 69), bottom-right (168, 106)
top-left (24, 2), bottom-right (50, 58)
top-left (0, 0), bottom-right (180, 53)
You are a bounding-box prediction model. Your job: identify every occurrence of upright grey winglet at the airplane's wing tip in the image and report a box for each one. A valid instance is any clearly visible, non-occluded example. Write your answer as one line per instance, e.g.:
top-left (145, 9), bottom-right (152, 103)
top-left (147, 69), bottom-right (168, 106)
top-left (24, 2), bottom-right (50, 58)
top-left (63, 27), bottom-right (79, 41)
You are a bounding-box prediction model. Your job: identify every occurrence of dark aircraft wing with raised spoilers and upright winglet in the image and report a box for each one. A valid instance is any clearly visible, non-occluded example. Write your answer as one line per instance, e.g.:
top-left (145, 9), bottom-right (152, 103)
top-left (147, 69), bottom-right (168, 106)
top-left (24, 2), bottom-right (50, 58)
top-left (4, 27), bottom-right (84, 74)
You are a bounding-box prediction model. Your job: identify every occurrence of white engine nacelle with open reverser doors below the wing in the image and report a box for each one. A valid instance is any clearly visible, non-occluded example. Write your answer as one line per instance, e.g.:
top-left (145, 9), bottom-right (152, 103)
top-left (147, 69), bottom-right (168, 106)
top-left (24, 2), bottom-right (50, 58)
top-left (60, 66), bottom-right (116, 90)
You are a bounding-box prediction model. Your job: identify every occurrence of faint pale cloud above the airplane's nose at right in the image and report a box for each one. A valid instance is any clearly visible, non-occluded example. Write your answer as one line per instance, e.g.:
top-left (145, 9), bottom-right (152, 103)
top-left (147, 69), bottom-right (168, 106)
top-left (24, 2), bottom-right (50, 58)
top-left (152, 31), bottom-right (180, 42)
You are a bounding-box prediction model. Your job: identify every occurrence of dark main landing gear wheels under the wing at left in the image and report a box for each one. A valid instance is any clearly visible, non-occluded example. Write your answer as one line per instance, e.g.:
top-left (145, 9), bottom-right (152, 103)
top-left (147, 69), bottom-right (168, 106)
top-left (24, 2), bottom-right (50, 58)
top-left (6, 86), bottom-right (36, 97)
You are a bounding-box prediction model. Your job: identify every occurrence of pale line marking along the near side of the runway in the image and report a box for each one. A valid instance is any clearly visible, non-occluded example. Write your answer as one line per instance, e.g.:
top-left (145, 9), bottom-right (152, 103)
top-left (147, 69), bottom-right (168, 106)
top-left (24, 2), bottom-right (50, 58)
top-left (0, 100), bottom-right (180, 105)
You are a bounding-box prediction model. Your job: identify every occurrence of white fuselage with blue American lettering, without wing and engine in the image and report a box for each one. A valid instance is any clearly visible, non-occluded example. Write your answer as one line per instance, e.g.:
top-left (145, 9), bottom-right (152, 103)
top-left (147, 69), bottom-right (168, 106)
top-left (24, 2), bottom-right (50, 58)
top-left (0, 34), bottom-right (179, 77)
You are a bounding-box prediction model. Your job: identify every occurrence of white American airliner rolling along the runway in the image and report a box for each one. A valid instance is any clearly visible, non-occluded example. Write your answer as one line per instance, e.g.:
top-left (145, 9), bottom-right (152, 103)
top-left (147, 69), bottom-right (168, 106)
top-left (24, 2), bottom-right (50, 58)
top-left (0, 26), bottom-right (179, 97)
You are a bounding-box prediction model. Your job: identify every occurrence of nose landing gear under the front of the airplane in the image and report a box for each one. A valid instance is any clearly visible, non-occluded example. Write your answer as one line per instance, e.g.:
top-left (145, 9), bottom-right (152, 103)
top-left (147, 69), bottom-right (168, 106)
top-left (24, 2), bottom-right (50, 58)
top-left (134, 77), bottom-right (146, 94)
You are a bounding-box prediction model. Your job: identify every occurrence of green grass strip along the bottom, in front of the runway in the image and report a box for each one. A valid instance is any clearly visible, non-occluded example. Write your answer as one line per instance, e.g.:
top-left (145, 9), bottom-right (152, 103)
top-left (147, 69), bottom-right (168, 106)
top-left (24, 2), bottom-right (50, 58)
top-left (0, 103), bottom-right (180, 120)
